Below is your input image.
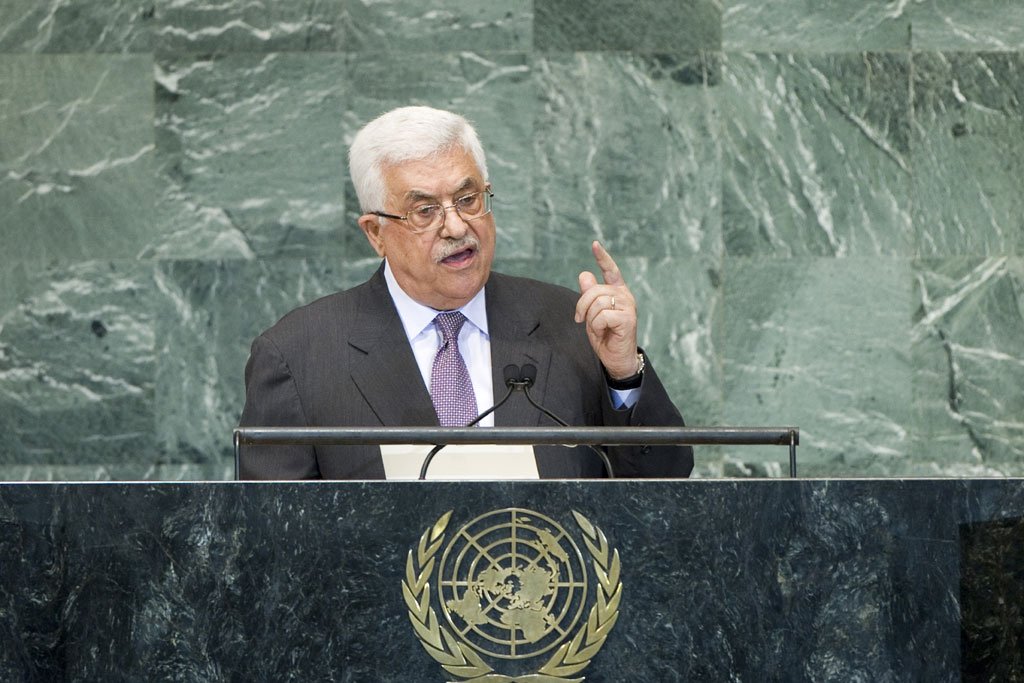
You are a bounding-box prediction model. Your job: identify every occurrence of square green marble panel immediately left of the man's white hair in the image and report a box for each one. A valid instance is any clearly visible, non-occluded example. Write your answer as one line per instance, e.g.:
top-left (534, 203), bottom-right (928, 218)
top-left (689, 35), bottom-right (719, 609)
top-left (146, 53), bottom-right (348, 259)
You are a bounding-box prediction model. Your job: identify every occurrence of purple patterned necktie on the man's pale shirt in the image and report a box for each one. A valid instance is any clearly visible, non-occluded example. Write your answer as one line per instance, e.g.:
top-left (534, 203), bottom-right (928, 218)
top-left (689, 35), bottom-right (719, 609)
top-left (430, 310), bottom-right (476, 427)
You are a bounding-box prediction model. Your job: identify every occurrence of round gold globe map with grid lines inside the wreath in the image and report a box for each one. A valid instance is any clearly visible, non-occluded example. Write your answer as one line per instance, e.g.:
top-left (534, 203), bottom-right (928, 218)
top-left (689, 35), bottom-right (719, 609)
top-left (438, 508), bottom-right (587, 659)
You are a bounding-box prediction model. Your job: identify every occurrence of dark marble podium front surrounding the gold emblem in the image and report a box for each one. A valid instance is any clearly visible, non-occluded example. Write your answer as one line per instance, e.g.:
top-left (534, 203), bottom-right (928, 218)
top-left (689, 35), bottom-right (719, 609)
top-left (0, 479), bottom-right (1024, 682)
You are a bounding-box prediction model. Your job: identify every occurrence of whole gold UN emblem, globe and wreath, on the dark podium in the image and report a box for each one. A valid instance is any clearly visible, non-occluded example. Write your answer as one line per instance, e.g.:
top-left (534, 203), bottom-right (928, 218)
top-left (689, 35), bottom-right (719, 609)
top-left (401, 508), bottom-right (623, 683)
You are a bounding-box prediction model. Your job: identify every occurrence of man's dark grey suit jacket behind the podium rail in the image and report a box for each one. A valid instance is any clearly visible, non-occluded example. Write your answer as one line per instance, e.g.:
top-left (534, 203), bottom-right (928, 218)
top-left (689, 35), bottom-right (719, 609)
top-left (235, 265), bottom-right (693, 479)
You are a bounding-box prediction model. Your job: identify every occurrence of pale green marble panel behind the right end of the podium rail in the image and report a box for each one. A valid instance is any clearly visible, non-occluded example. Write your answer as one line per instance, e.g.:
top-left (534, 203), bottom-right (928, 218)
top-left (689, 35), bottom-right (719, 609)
top-left (722, 257), bottom-right (913, 476)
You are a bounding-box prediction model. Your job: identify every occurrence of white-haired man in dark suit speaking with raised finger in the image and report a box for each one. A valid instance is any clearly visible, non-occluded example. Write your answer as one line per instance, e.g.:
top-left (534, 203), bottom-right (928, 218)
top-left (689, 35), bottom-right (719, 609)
top-left (241, 106), bottom-right (693, 479)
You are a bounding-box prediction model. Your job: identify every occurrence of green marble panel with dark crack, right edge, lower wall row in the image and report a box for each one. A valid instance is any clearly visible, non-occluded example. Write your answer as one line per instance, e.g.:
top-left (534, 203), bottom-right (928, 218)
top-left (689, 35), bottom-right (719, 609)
top-left (912, 257), bottom-right (1024, 476)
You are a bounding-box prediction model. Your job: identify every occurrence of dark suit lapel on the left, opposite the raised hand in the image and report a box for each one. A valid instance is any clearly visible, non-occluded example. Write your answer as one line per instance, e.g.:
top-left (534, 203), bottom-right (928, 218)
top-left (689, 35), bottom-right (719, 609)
top-left (348, 266), bottom-right (437, 427)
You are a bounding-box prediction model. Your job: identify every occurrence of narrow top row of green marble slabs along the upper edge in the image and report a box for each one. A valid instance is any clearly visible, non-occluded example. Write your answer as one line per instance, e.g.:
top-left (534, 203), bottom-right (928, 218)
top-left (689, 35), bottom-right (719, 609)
top-left (6, 0), bottom-right (1024, 53)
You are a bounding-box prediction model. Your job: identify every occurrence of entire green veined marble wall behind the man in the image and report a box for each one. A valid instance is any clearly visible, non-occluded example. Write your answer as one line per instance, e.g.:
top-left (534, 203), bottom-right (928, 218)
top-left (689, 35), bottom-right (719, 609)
top-left (0, 0), bottom-right (1024, 480)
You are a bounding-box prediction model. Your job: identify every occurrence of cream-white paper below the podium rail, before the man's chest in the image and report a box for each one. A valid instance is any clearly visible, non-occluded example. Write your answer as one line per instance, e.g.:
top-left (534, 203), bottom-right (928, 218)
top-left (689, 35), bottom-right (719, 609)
top-left (381, 444), bottom-right (541, 481)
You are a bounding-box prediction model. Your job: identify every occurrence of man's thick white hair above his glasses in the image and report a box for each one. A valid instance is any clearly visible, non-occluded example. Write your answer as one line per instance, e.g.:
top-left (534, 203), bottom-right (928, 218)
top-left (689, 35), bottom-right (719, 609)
top-left (348, 106), bottom-right (487, 213)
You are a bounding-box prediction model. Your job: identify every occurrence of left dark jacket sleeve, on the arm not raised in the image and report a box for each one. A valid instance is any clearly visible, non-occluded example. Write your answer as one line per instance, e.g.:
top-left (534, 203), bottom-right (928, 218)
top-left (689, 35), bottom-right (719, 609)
top-left (239, 335), bottom-right (321, 479)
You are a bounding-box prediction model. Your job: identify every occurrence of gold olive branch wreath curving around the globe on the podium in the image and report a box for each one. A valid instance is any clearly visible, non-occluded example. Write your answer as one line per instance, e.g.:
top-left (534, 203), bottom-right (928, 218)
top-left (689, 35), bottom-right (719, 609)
top-left (401, 510), bottom-right (623, 683)
